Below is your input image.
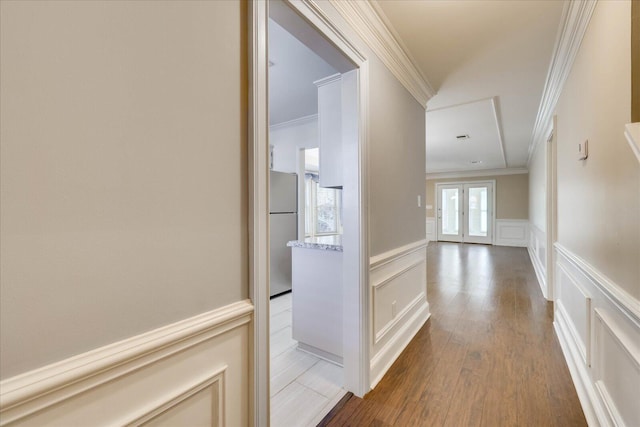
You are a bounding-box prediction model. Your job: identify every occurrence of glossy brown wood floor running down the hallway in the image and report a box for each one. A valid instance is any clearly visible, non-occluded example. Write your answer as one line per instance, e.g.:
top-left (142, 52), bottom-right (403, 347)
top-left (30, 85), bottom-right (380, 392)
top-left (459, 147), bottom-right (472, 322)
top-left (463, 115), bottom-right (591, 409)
top-left (321, 242), bottom-right (587, 427)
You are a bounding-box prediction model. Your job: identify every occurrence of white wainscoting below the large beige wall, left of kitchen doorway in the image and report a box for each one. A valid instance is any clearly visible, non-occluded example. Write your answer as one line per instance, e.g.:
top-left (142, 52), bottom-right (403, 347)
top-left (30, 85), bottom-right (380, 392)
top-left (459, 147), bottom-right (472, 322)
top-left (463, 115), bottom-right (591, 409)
top-left (0, 301), bottom-right (253, 426)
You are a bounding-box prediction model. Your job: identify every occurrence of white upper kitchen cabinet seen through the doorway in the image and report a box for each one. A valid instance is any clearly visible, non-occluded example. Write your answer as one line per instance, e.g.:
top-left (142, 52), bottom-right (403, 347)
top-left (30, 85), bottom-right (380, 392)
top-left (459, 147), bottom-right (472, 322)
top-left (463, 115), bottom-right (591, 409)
top-left (314, 74), bottom-right (342, 188)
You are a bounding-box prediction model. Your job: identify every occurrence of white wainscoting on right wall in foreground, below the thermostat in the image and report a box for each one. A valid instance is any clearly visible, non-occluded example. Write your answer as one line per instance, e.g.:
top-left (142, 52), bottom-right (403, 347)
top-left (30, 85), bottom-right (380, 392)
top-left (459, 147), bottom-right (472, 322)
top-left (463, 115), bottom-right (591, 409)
top-left (554, 243), bottom-right (640, 426)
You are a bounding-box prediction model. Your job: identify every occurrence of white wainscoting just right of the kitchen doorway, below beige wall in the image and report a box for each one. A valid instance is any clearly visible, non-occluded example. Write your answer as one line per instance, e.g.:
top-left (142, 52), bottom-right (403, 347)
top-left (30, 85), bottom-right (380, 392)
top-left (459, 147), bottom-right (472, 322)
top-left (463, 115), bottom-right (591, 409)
top-left (370, 240), bottom-right (430, 388)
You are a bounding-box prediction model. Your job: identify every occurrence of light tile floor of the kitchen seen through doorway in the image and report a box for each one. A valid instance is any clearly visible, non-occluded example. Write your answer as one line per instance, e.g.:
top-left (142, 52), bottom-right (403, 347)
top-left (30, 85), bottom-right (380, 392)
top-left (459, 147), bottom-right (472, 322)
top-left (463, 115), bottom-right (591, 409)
top-left (270, 293), bottom-right (346, 427)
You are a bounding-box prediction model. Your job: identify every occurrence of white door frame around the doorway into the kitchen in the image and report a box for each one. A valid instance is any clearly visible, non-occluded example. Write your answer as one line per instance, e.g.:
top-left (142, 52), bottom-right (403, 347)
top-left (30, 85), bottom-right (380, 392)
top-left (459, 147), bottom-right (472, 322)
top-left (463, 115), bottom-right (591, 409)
top-left (248, 0), bottom-right (370, 426)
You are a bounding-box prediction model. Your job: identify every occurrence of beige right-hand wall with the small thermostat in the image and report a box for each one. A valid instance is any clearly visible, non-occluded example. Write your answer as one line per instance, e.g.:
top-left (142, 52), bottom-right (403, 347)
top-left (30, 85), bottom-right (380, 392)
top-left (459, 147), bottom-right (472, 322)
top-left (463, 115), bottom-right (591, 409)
top-left (556, 1), bottom-right (640, 298)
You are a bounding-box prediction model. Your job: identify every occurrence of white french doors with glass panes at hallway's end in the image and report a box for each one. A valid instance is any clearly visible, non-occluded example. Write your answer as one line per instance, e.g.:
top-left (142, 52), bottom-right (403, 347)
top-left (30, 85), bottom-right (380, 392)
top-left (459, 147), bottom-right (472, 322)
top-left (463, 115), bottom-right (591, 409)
top-left (436, 181), bottom-right (494, 244)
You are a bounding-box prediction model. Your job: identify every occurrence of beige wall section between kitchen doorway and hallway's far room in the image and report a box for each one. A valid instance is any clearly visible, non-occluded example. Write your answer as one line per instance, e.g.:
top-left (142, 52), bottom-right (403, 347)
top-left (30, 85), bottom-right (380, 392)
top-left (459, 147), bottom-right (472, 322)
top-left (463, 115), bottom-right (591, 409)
top-left (369, 54), bottom-right (426, 256)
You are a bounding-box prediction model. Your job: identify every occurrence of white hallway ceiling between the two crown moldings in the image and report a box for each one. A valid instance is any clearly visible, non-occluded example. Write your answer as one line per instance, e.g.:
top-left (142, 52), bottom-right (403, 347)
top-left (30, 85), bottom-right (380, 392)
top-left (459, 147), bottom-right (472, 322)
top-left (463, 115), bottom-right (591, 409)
top-left (374, 0), bottom-right (564, 173)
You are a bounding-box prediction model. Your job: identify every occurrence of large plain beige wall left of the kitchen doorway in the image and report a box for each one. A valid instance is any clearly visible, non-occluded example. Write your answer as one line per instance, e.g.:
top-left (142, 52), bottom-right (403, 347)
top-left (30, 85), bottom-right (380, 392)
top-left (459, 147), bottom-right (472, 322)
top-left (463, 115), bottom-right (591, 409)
top-left (0, 1), bottom-right (248, 378)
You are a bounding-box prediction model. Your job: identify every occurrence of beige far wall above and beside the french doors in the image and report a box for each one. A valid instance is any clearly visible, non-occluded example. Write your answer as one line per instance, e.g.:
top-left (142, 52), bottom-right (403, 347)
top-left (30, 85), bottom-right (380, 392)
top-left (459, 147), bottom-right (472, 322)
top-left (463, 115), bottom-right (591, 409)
top-left (426, 174), bottom-right (529, 219)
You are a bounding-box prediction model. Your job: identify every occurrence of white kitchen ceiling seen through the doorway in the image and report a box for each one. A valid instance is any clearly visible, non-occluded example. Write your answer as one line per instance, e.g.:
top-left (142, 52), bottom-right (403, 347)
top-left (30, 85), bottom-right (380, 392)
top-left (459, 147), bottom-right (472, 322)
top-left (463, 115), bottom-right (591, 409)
top-left (269, 19), bottom-right (336, 125)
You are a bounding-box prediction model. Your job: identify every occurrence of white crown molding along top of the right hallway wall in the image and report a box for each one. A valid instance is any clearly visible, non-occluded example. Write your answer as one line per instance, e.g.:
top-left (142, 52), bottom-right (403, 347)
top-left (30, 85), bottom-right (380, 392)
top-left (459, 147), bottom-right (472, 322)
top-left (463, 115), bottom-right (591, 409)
top-left (527, 0), bottom-right (597, 164)
